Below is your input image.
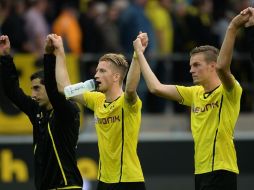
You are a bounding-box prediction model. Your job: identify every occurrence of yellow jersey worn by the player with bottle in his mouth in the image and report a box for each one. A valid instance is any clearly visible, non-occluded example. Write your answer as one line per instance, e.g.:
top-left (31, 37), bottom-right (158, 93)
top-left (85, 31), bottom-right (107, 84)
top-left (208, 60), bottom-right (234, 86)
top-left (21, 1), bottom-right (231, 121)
top-left (83, 92), bottom-right (144, 183)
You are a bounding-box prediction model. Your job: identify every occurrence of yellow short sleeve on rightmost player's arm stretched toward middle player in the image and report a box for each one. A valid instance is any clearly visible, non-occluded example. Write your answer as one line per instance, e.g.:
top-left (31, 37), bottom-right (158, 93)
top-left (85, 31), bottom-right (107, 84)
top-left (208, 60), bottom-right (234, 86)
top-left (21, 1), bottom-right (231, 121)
top-left (176, 85), bottom-right (194, 106)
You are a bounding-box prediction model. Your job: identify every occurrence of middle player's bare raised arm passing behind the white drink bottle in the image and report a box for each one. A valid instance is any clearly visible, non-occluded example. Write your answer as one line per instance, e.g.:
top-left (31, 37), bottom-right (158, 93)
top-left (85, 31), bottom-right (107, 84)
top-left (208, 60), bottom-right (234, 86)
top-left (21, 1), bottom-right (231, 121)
top-left (46, 34), bottom-right (85, 104)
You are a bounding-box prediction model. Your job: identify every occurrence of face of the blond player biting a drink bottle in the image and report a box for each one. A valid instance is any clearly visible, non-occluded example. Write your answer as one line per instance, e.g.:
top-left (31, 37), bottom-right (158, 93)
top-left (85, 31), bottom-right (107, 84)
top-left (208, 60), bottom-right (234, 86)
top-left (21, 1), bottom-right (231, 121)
top-left (94, 61), bottom-right (114, 93)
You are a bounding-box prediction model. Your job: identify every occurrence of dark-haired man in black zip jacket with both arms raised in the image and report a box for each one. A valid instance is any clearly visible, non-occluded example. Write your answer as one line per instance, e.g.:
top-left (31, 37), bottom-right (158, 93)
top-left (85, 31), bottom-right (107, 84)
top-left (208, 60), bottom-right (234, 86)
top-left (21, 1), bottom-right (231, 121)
top-left (0, 35), bottom-right (83, 190)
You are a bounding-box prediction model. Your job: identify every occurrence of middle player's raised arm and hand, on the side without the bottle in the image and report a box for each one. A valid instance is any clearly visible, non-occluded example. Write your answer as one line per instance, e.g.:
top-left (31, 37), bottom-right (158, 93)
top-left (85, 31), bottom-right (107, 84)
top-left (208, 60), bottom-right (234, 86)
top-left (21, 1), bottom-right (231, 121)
top-left (125, 32), bottom-right (148, 104)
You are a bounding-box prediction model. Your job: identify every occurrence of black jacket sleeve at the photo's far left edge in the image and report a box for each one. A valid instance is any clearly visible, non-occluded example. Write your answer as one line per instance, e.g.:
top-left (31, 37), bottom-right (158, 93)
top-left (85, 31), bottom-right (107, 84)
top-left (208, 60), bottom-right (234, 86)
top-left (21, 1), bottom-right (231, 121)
top-left (0, 55), bottom-right (38, 116)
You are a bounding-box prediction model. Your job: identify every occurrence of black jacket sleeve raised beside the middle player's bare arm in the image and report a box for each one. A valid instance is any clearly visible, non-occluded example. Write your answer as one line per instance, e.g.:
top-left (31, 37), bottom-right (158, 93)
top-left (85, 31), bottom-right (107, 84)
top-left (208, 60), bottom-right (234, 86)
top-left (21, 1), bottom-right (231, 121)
top-left (43, 54), bottom-right (79, 120)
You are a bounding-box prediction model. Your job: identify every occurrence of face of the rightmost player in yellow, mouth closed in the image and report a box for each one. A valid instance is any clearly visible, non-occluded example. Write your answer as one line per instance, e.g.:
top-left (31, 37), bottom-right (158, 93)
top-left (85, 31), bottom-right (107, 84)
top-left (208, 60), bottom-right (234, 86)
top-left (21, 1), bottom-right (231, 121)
top-left (190, 53), bottom-right (212, 85)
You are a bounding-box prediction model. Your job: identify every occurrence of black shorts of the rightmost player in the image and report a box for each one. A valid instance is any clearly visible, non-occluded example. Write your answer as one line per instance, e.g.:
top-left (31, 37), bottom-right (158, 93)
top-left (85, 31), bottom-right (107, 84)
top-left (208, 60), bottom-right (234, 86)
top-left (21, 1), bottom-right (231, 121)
top-left (195, 170), bottom-right (237, 190)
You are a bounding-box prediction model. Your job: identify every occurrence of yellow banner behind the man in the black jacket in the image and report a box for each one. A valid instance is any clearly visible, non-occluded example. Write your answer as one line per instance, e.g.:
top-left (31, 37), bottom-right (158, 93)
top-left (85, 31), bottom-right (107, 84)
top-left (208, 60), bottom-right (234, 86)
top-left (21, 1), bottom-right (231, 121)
top-left (0, 54), bottom-right (80, 134)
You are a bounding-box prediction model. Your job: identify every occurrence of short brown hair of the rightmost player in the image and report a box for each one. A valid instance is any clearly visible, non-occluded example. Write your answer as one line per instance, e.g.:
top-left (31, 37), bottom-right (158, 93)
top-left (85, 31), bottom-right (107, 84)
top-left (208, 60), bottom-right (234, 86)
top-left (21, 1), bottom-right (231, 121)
top-left (190, 45), bottom-right (219, 62)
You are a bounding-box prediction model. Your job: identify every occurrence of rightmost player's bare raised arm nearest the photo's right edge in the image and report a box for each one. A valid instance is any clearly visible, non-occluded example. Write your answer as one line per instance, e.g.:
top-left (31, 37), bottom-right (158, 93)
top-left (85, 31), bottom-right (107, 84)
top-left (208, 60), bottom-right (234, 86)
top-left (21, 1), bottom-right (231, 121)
top-left (216, 14), bottom-right (249, 90)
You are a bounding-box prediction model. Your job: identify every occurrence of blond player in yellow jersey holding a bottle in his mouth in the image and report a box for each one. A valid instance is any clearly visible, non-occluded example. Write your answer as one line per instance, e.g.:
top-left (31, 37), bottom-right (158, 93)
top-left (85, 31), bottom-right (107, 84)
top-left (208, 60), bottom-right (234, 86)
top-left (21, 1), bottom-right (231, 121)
top-left (47, 33), bottom-right (148, 190)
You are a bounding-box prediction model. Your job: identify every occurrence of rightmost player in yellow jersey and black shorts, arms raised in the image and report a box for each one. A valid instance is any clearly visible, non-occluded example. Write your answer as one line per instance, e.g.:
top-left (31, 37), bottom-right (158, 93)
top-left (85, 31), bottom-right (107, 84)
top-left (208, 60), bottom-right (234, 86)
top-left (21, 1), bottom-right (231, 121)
top-left (133, 11), bottom-right (249, 190)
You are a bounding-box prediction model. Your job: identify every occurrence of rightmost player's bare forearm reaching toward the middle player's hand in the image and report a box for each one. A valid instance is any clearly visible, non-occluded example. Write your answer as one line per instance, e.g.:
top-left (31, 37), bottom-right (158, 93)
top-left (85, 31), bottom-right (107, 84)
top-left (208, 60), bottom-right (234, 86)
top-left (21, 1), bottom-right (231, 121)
top-left (137, 52), bottom-right (160, 94)
